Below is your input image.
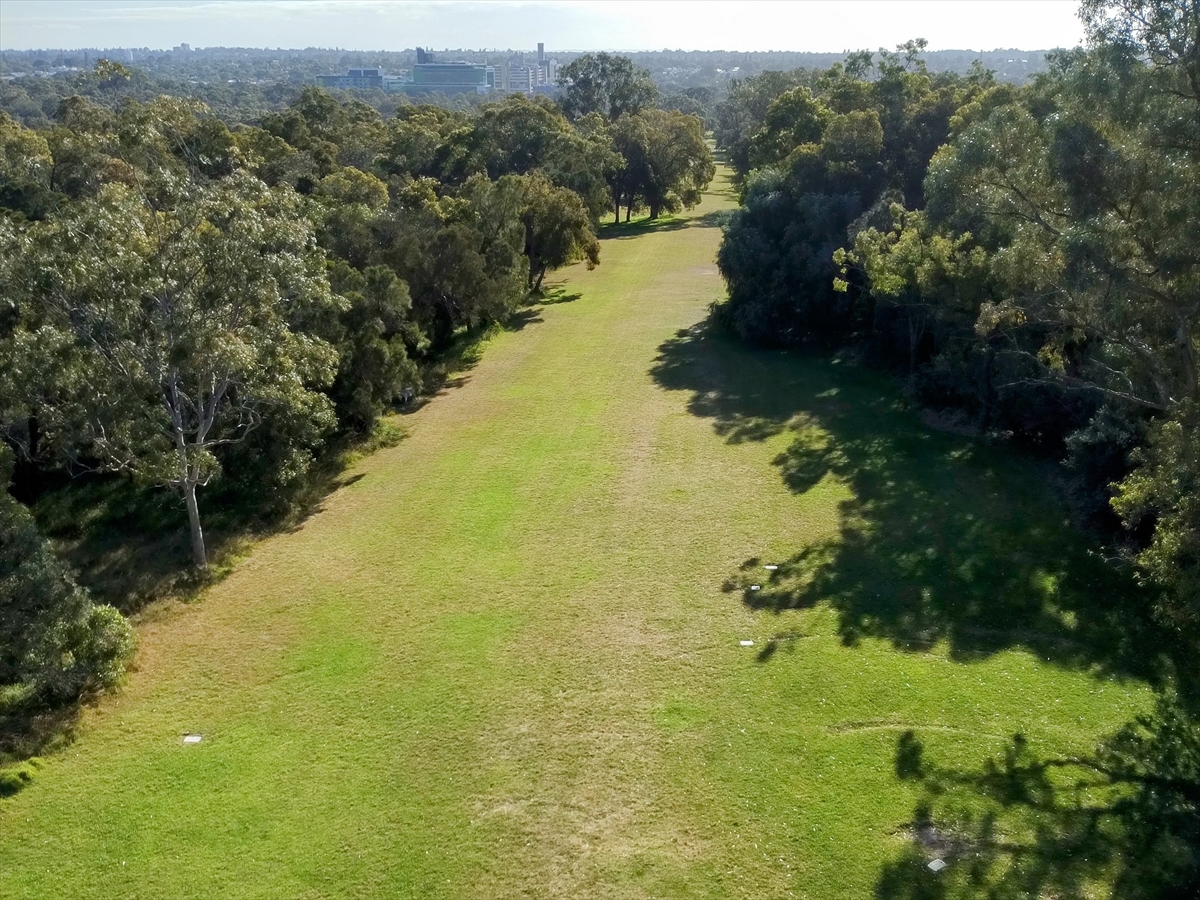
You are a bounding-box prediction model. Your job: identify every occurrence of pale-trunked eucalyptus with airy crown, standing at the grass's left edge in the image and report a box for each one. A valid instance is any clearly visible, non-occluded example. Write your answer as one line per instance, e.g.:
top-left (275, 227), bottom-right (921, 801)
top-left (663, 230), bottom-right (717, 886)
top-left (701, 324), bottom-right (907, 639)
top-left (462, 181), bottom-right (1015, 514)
top-left (0, 175), bottom-right (337, 566)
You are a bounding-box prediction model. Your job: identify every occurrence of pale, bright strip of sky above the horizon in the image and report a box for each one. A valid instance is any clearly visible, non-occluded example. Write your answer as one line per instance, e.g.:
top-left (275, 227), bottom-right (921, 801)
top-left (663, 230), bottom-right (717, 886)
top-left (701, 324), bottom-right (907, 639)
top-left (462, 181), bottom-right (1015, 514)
top-left (0, 0), bottom-right (1082, 53)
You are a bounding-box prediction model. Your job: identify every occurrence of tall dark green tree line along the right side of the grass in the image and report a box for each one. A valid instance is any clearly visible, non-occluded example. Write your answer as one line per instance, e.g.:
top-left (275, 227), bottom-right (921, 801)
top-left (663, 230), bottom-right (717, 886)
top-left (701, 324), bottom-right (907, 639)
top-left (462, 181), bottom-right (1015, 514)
top-left (715, 0), bottom-right (1200, 896)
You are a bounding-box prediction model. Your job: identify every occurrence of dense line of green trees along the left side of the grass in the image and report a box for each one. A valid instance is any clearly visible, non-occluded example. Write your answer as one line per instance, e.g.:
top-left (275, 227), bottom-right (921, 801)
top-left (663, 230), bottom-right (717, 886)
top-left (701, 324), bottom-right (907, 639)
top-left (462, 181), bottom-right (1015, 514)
top-left (0, 56), bottom-right (713, 734)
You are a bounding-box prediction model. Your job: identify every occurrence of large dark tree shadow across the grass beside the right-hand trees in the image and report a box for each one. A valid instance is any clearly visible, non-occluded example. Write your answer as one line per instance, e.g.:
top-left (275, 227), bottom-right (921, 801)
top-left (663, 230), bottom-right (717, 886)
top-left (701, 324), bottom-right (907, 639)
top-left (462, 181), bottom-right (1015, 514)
top-left (653, 325), bottom-right (1165, 682)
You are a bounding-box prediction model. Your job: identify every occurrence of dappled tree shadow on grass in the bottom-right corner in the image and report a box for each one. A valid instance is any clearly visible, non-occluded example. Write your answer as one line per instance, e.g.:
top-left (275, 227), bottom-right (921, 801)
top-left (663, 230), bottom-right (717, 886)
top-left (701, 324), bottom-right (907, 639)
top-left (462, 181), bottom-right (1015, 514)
top-left (875, 694), bottom-right (1200, 900)
